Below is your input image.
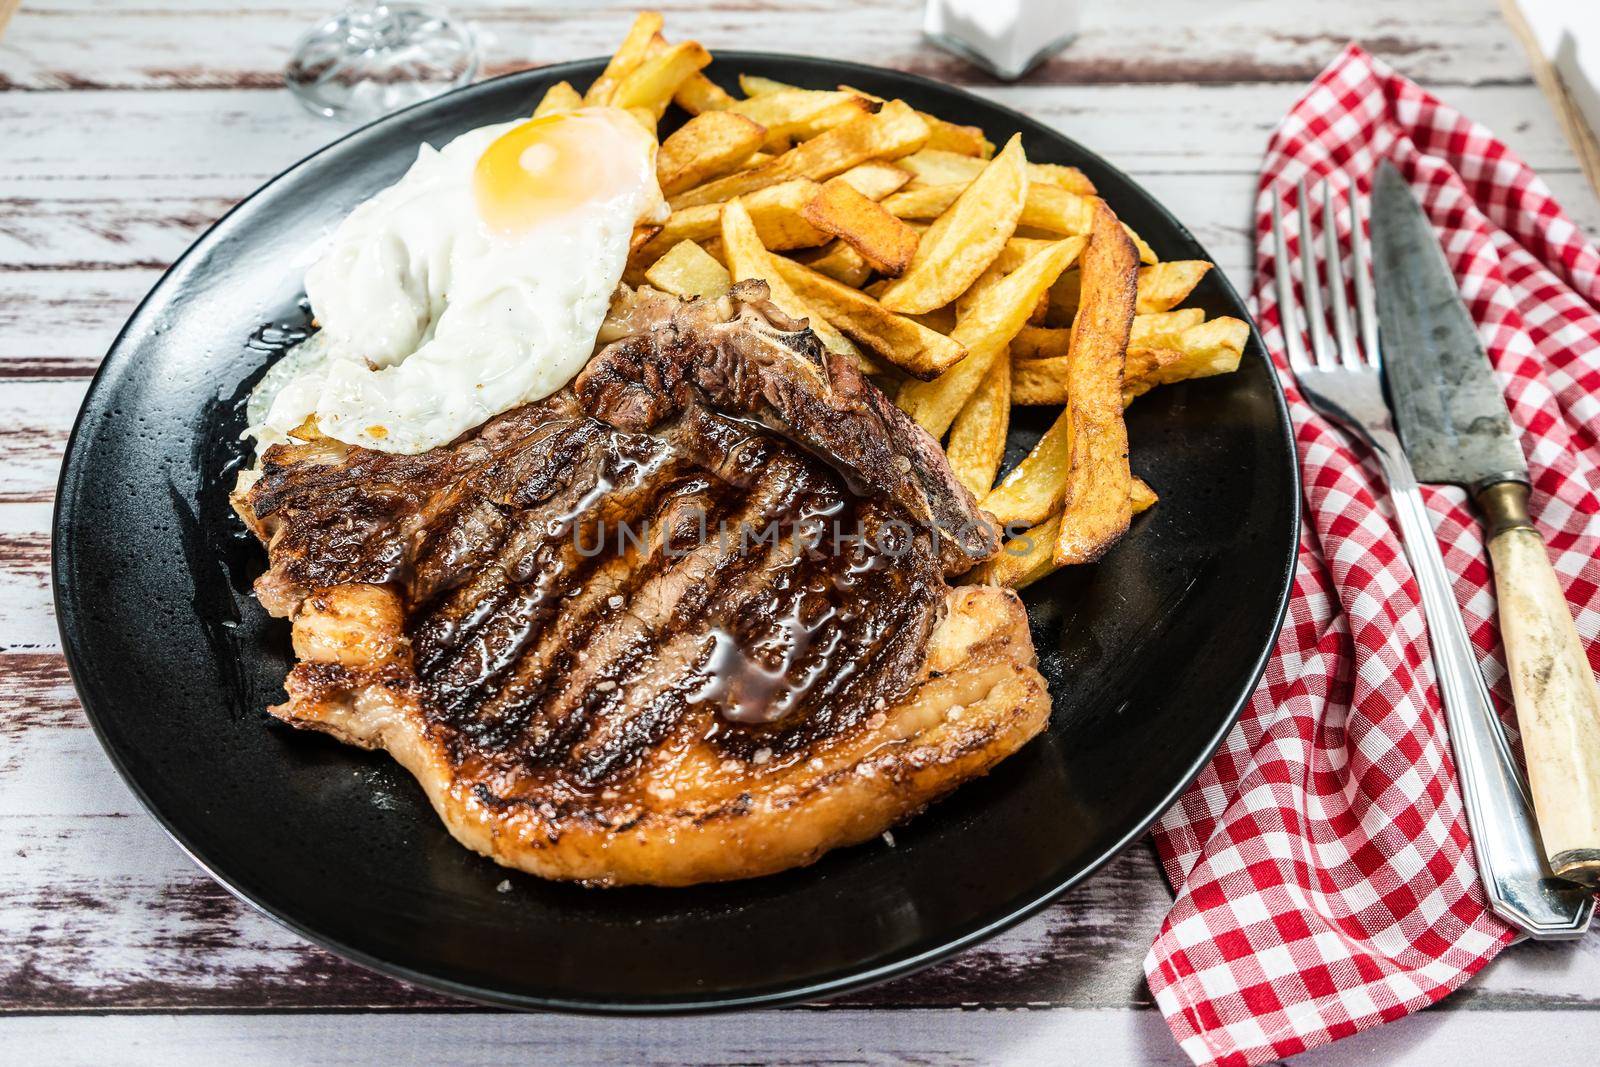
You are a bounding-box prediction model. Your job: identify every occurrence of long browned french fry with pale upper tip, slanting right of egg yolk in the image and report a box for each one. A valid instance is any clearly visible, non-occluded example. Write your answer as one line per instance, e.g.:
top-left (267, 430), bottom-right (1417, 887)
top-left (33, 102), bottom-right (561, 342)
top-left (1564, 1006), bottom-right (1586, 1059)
top-left (670, 101), bottom-right (928, 210)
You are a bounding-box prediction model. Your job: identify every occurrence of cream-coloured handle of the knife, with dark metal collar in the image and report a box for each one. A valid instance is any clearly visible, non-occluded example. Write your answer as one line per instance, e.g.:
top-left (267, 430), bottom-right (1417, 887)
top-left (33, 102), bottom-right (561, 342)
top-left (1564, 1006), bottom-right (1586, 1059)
top-left (1478, 482), bottom-right (1600, 888)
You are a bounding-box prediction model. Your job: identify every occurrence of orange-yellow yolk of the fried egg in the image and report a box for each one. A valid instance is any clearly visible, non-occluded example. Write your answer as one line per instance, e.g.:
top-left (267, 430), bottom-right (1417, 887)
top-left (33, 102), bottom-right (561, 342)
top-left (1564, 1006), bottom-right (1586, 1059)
top-left (472, 107), bottom-right (654, 232)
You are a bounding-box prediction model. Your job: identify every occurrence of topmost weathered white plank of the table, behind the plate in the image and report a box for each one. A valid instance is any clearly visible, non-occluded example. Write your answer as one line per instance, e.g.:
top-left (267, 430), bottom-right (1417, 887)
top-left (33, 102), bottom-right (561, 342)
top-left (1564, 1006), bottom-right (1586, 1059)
top-left (0, 0), bottom-right (1531, 91)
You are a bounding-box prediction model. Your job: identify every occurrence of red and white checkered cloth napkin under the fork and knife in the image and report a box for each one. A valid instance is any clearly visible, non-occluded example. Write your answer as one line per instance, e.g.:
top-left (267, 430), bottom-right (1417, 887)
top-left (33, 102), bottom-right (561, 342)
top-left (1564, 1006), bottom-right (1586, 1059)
top-left (1144, 45), bottom-right (1600, 1064)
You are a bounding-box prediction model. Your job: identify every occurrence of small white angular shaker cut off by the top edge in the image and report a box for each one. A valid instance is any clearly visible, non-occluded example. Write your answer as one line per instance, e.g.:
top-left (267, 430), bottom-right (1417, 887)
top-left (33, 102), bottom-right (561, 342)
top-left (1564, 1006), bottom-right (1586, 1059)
top-left (922, 0), bottom-right (1082, 82)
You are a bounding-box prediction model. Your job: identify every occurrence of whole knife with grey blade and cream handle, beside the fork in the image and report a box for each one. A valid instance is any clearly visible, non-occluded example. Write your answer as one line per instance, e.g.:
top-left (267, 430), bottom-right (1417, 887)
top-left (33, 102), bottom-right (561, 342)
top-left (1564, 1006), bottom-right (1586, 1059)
top-left (1371, 163), bottom-right (1600, 889)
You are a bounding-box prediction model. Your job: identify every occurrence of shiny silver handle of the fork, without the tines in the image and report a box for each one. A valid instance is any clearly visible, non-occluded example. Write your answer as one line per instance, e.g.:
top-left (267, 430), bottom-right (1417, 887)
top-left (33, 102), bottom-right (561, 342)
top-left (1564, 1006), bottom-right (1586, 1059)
top-left (1365, 426), bottom-right (1590, 939)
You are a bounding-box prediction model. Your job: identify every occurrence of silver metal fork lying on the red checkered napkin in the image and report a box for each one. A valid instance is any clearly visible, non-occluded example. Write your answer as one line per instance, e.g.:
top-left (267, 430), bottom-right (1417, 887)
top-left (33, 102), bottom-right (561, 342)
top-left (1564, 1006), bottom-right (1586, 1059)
top-left (1272, 174), bottom-right (1582, 937)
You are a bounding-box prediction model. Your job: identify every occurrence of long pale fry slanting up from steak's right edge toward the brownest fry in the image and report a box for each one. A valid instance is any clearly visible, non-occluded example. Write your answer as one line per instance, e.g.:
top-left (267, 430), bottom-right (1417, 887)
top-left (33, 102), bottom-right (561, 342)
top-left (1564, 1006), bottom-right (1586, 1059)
top-left (894, 242), bottom-right (1078, 438)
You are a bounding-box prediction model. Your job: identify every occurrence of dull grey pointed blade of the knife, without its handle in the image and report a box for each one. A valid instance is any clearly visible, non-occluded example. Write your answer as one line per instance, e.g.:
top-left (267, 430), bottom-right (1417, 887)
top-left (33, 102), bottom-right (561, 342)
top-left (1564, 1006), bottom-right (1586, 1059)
top-left (1373, 162), bottom-right (1528, 493)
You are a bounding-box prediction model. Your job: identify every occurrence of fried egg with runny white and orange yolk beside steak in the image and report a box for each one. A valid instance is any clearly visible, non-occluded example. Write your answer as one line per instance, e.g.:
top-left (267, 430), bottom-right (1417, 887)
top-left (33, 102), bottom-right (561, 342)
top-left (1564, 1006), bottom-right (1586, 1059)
top-left (248, 107), bottom-right (666, 453)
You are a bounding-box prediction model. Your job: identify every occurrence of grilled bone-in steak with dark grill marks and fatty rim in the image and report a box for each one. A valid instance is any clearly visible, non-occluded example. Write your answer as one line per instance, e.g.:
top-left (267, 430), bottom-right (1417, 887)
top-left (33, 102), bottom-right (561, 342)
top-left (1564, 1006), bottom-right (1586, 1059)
top-left (235, 283), bottom-right (1050, 885)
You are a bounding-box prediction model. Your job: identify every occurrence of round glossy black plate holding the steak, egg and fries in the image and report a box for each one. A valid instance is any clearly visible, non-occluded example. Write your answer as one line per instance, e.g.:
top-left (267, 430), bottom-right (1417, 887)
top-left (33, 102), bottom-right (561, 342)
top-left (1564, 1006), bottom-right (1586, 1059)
top-left (54, 53), bottom-right (1299, 1013)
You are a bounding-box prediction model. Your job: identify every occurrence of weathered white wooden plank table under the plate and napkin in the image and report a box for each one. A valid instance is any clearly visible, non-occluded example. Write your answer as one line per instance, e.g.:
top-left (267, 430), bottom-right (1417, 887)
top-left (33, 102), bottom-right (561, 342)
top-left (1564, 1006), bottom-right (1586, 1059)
top-left (9, 0), bottom-right (1600, 1064)
